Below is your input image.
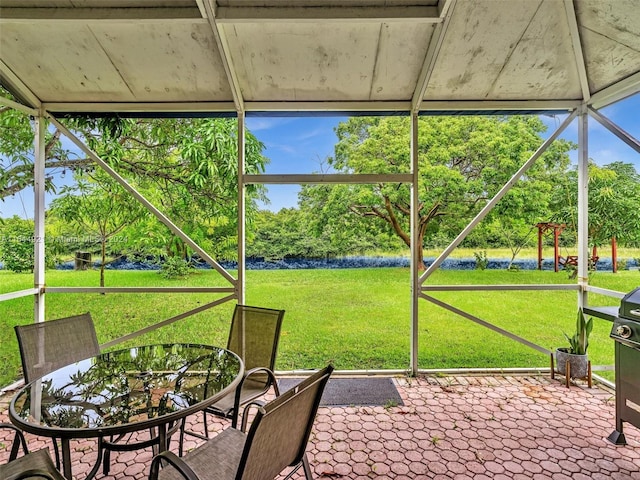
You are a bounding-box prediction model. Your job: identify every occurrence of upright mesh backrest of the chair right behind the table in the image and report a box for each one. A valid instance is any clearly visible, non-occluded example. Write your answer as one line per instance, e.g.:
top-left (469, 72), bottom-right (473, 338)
top-left (227, 305), bottom-right (284, 370)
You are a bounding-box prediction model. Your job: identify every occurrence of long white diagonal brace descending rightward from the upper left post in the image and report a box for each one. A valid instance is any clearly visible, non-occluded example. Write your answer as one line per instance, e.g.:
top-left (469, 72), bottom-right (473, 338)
top-left (47, 114), bottom-right (236, 286)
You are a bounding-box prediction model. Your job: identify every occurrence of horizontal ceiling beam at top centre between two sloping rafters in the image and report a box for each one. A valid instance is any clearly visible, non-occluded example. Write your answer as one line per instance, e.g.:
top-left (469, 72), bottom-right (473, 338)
top-left (216, 6), bottom-right (441, 23)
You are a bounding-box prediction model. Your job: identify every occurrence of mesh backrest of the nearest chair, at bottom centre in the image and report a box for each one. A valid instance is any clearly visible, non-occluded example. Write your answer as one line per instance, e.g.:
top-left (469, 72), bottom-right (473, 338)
top-left (236, 365), bottom-right (333, 480)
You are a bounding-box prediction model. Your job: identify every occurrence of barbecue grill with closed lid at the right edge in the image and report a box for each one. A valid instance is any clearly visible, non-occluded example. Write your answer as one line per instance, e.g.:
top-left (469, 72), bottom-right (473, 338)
top-left (609, 287), bottom-right (640, 445)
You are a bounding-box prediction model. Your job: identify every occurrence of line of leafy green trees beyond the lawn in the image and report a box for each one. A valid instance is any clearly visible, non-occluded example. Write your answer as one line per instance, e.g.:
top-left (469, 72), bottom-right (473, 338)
top-left (0, 88), bottom-right (640, 273)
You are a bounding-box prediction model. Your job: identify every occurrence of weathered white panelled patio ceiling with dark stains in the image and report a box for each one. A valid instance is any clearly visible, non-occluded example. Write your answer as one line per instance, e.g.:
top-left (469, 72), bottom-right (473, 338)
top-left (0, 0), bottom-right (640, 113)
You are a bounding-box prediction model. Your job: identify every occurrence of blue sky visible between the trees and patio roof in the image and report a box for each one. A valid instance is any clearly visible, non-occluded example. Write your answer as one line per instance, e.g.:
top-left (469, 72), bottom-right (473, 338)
top-left (0, 94), bottom-right (640, 218)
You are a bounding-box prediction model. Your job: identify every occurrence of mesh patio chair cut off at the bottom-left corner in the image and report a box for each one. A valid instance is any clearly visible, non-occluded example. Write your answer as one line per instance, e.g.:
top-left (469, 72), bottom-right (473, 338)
top-left (0, 423), bottom-right (65, 480)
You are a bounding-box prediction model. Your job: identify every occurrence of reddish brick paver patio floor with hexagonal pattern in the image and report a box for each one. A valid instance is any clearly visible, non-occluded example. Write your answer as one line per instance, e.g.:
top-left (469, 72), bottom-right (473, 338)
top-left (0, 376), bottom-right (640, 480)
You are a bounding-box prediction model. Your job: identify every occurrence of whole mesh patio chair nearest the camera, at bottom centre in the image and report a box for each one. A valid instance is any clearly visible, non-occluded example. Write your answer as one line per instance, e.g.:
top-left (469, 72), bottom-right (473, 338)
top-left (149, 365), bottom-right (333, 480)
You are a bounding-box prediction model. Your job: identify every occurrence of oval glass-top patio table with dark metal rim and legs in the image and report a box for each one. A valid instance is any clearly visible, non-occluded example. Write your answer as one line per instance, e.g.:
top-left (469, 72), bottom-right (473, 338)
top-left (9, 343), bottom-right (244, 479)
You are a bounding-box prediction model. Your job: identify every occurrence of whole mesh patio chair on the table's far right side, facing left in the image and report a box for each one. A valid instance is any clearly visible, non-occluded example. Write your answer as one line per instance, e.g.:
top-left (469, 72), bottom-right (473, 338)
top-left (180, 305), bottom-right (284, 453)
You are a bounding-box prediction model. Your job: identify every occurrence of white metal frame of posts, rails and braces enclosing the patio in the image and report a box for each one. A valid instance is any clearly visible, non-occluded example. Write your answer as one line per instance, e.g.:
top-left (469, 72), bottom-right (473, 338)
top-left (0, 97), bottom-right (640, 374)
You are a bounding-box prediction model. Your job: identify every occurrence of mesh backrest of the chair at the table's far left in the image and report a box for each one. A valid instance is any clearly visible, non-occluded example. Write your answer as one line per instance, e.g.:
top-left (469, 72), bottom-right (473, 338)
top-left (15, 312), bottom-right (100, 383)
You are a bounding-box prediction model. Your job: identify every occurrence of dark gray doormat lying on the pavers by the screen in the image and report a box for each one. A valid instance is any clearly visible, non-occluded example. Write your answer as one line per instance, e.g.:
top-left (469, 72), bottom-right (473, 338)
top-left (278, 377), bottom-right (404, 406)
